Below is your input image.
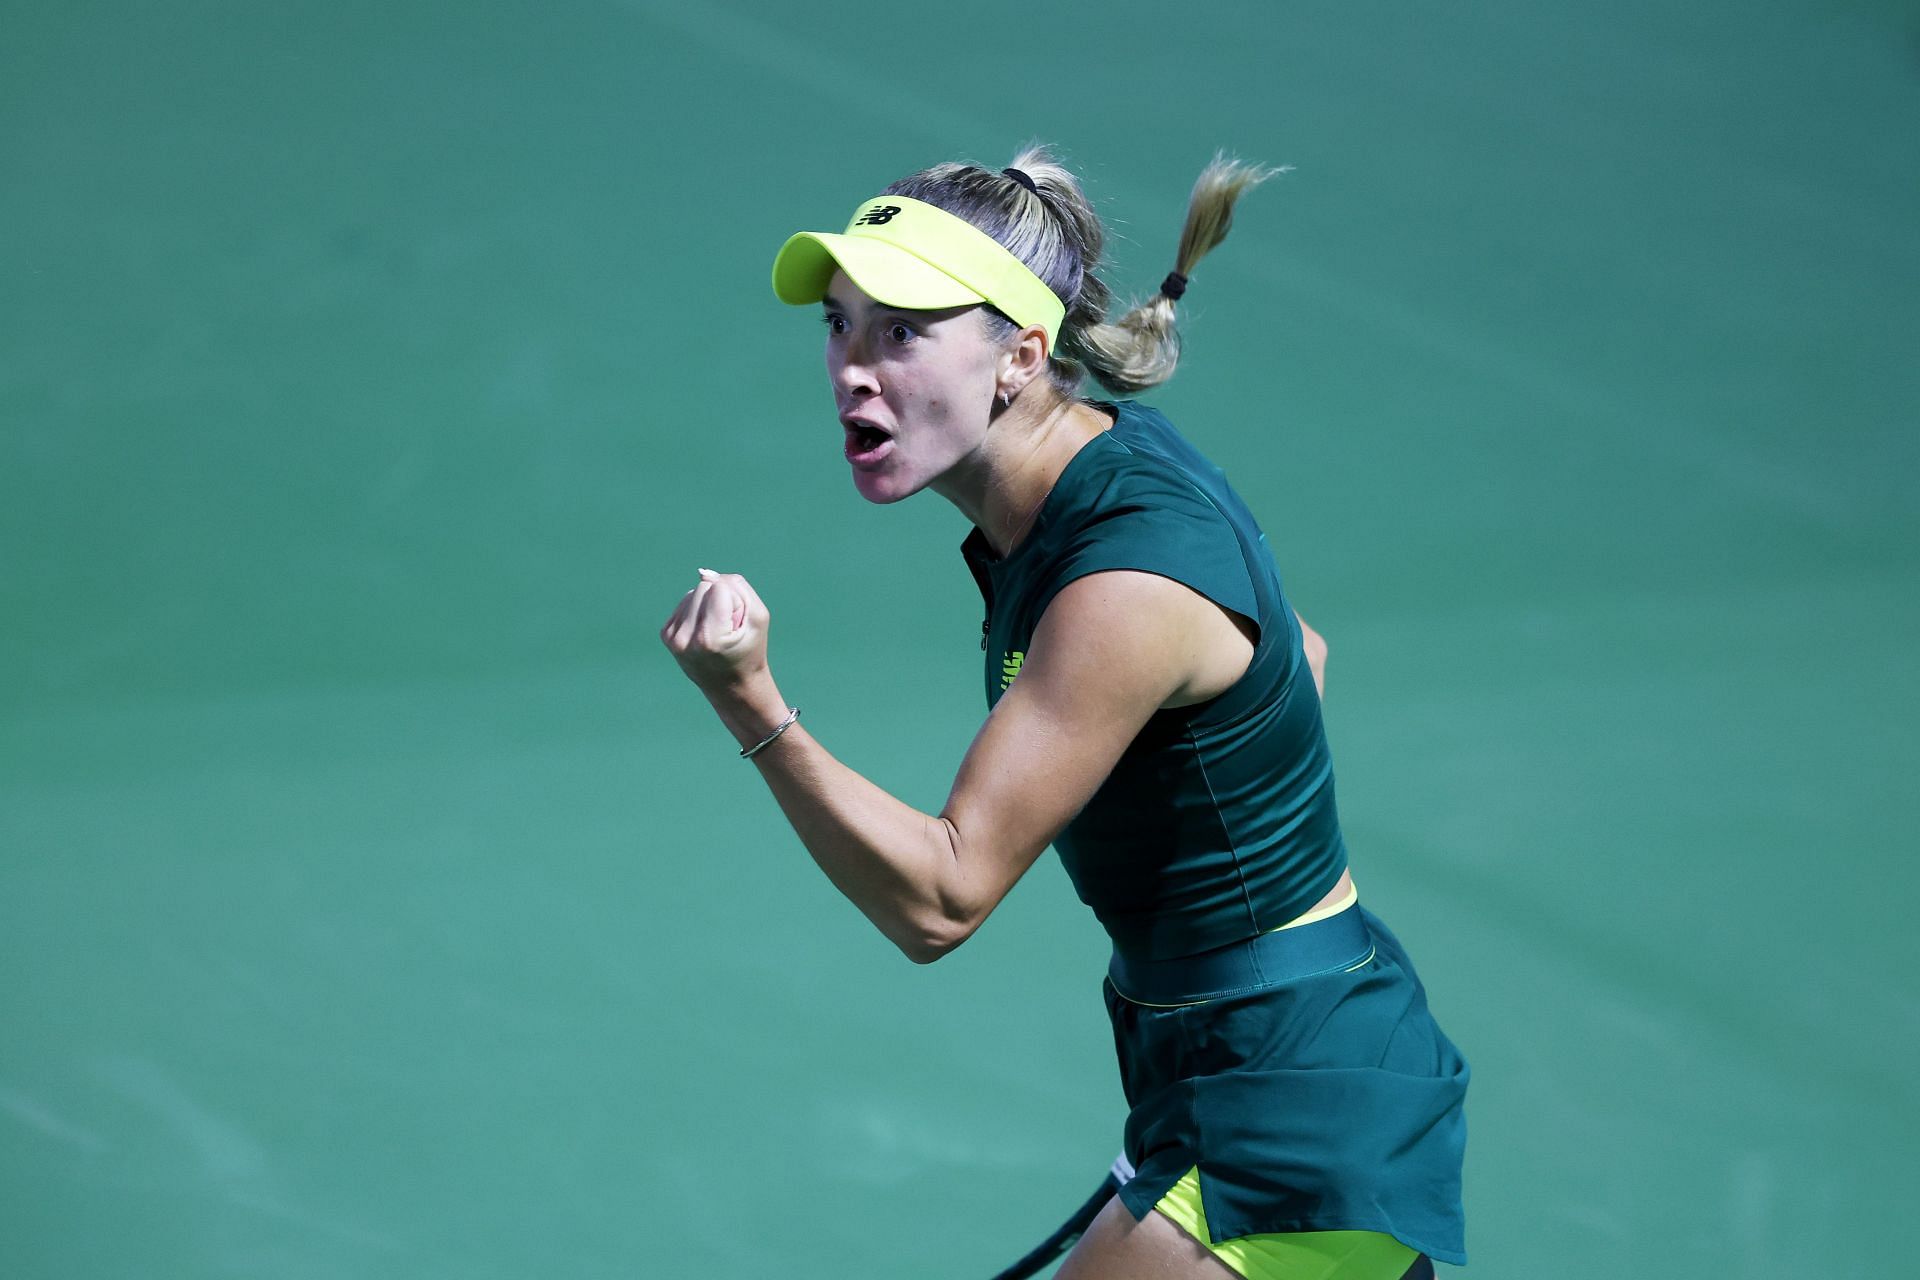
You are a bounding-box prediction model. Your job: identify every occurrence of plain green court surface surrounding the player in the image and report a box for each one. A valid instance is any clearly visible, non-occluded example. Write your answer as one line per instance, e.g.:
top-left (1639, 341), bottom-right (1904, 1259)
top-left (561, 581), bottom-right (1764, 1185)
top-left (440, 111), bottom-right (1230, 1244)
top-left (0, 0), bottom-right (1920, 1280)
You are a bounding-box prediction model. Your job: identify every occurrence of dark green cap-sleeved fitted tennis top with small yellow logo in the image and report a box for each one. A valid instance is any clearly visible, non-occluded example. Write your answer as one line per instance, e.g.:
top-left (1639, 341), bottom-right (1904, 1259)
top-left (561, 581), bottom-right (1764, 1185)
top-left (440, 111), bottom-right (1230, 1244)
top-left (962, 401), bottom-right (1346, 960)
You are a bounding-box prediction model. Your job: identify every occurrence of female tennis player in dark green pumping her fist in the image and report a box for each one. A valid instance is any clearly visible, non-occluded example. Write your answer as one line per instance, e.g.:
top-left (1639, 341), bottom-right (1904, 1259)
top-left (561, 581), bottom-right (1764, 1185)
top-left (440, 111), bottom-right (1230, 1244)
top-left (660, 148), bottom-right (1467, 1280)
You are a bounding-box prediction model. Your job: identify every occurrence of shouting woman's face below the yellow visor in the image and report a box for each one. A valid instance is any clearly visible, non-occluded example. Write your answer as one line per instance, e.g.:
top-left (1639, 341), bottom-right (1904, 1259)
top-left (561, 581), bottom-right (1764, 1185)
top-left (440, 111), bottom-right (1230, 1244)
top-left (822, 271), bottom-right (1004, 503)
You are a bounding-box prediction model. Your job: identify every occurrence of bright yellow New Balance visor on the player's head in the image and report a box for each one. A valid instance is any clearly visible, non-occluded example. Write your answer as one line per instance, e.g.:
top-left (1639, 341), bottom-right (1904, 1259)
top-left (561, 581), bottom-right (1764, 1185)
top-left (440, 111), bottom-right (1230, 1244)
top-left (774, 196), bottom-right (1068, 353)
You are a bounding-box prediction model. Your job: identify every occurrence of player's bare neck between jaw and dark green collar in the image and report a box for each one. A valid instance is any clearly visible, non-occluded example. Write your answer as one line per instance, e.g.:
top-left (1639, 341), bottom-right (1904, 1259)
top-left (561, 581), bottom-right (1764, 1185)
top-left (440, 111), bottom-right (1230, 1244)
top-left (933, 393), bottom-right (1110, 558)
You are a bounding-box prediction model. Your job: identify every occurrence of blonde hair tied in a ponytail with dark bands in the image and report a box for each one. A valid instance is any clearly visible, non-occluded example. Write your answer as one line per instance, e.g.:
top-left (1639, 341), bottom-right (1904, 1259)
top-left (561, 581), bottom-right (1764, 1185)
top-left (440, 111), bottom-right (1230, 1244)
top-left (887, 144), bottom-right (1284, 395)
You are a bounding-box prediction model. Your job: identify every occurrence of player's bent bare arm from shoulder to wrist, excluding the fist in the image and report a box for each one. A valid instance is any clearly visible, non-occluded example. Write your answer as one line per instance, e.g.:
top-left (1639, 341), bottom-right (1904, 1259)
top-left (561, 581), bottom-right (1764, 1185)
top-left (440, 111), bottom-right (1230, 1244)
top-left (708, 572), bottom-right (1217, 963)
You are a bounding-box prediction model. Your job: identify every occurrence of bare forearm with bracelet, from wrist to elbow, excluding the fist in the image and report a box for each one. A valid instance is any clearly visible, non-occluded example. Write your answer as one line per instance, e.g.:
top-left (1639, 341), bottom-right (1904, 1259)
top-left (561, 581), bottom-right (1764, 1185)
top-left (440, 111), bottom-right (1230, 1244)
top-left (708, 677), bottom-right (979, 961)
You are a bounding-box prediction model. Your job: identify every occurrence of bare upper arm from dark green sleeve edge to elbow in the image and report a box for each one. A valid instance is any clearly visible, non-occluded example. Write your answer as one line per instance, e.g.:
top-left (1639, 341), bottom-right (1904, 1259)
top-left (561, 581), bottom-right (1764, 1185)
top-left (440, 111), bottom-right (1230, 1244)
top-left (941, 572), bottom-right (1217, 915)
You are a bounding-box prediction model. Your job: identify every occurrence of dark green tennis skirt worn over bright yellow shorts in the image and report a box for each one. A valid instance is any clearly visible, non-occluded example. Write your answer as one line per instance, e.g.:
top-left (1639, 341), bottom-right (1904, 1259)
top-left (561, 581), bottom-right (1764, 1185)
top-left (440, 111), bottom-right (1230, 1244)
top-left (1106, 906), bottom-right (1467, 1265)
